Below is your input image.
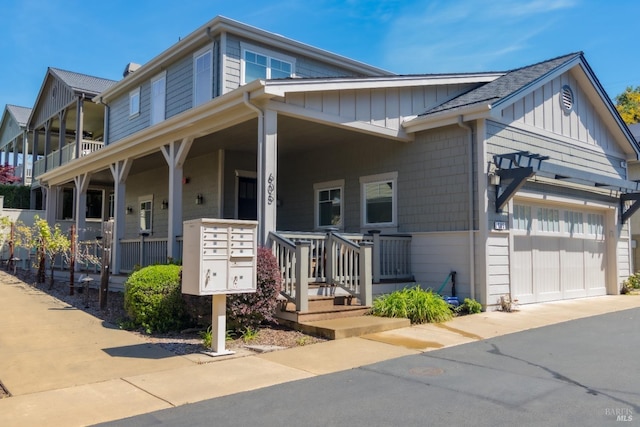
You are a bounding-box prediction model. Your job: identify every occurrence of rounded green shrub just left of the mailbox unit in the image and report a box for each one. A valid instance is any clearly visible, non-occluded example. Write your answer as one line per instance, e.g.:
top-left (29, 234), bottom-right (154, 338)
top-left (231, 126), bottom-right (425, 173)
top-left (124, 265), bottom-right (188, 334)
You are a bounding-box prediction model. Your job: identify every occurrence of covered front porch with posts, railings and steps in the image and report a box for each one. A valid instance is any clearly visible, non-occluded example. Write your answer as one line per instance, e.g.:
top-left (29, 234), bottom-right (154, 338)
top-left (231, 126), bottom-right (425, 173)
top-left (39, 81), bottom-right (420, 311)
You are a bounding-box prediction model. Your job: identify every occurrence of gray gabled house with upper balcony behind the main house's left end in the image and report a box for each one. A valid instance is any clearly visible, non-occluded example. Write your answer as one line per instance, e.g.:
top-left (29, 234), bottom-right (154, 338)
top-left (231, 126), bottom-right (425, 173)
top-left (28, 68), bottom-right (115, 238)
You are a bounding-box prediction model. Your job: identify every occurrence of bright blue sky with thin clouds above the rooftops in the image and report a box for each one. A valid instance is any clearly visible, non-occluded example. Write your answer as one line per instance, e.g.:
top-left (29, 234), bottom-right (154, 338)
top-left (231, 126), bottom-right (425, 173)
top-left (0, 0), bottom-right (640, 108)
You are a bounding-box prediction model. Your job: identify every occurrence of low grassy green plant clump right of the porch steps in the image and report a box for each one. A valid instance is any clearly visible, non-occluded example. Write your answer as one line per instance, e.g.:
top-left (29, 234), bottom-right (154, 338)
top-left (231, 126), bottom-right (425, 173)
top-left (371, 286), bottom-right (453, 324)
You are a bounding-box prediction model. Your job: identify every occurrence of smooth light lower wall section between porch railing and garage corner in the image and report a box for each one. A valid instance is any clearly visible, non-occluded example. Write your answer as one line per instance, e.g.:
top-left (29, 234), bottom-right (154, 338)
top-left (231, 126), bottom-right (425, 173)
top-left (411, 232), bottom-right (471, 301)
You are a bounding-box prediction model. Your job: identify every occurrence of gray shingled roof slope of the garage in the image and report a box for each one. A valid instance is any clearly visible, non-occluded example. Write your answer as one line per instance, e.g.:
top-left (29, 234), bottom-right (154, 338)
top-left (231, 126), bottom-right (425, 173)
top-left (421, 52), bottom-right (582, 116)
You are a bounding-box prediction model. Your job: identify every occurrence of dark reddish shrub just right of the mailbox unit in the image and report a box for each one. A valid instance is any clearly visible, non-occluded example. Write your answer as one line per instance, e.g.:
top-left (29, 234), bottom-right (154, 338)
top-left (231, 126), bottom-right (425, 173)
top-left (227, 248), bottom-right (282, 335)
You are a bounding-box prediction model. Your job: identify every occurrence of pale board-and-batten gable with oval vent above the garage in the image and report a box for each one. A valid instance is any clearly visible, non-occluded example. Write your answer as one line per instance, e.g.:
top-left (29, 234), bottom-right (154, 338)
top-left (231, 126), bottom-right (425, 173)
top-left (502, 72), bottom-right (620, 152)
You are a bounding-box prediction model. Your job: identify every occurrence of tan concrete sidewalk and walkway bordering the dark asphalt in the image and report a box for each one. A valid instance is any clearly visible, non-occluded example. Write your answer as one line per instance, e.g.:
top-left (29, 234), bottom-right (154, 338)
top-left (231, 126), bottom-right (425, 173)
top-left (0, 274), bottom-right (640, 427)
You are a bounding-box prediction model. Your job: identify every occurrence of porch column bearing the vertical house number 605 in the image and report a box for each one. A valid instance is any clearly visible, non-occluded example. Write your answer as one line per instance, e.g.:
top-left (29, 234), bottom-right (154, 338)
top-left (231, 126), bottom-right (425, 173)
top-left (258, 110), bottom-right (278, 245)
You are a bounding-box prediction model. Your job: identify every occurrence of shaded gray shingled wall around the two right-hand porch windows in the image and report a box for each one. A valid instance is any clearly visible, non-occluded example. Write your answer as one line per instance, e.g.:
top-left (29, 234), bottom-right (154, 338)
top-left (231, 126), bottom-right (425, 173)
top-left (277, 126), bottom-right (469, 233)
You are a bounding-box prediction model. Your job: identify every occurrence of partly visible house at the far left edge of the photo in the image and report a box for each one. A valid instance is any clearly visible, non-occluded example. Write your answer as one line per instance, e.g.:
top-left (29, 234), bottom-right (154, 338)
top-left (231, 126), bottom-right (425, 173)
top-left (0, 105), bottom-right (31, 185)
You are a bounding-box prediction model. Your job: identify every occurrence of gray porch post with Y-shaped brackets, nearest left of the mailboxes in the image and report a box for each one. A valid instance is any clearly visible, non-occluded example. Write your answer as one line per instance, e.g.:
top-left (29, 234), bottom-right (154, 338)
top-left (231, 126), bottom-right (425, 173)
top-left (161, 137), bottom-right (193, 260)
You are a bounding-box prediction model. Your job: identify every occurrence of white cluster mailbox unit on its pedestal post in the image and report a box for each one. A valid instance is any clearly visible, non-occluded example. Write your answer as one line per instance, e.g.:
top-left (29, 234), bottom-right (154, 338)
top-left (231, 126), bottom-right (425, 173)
top-left (182, 218), bottom-right (258, 356)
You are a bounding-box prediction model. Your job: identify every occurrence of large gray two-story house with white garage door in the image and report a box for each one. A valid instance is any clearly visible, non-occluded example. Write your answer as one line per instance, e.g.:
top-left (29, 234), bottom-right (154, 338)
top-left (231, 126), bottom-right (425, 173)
top-left (23, 17), bottom-right (639, 309)
